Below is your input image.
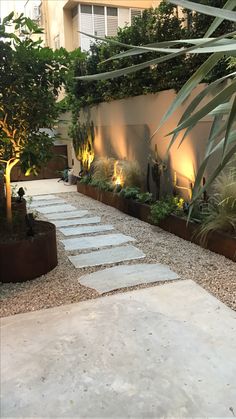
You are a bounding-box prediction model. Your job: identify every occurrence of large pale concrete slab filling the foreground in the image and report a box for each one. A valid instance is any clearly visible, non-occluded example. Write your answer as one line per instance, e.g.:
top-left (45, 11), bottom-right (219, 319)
top-left (1, 281), bottom-right (236, 418)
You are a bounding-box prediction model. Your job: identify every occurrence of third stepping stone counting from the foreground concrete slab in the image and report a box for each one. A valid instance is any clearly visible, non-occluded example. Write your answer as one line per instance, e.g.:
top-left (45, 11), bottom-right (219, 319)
top-left (61, 234), bottom-right (136, 250)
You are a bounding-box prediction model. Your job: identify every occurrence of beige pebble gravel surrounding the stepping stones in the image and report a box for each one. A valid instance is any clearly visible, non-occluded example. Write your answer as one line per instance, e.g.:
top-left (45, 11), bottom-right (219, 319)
top-left (0, 192), bottom-right (236, 317)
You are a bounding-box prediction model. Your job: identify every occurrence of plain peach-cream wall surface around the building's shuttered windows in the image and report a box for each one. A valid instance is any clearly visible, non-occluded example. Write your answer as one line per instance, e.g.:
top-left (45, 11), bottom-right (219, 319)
top-left (41, 0), bottom-right (159, 51)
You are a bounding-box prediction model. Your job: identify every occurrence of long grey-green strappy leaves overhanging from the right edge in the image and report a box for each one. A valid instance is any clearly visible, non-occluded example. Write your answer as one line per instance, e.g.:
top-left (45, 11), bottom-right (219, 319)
top-left (76, 0), bottom-right (236, 208)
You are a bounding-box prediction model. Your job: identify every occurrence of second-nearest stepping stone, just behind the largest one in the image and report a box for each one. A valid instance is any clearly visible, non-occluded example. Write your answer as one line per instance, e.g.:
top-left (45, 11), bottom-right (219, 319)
top-left (69, 245), bottom-right (145, 268)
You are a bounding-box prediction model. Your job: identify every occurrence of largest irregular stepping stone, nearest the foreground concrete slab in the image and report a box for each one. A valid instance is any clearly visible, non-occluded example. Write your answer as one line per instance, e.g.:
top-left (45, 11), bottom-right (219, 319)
top-left (79, 263), bottom-right (179, 293)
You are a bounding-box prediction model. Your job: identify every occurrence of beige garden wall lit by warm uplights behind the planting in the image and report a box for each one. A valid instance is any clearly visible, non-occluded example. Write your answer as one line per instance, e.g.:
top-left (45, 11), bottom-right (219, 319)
top-left (80, 85), bottom-right (218, 197)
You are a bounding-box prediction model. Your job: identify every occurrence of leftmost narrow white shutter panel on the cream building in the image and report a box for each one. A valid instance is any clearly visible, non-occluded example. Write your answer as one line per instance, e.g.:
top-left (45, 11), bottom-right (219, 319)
top-left (80, 5), bottom-right (94, 51)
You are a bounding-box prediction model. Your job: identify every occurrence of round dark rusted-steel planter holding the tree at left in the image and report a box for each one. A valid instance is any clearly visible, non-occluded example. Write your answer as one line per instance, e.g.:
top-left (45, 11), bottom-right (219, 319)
top-left (0, 221), bottom-right (57, 282)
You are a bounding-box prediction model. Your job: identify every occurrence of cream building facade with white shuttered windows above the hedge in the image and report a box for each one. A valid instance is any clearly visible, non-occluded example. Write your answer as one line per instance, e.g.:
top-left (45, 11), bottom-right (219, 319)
top-left (41, 0), bottom-right (159, 51)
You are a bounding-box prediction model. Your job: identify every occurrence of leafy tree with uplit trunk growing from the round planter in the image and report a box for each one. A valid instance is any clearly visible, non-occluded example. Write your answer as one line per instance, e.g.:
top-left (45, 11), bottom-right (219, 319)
top-left (0, 13), bottom-right (83, 223)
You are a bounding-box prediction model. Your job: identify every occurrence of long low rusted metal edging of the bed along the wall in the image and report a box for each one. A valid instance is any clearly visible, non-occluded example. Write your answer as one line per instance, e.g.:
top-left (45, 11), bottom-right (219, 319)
top-left (77, 182), bottom-right (236, 261)
